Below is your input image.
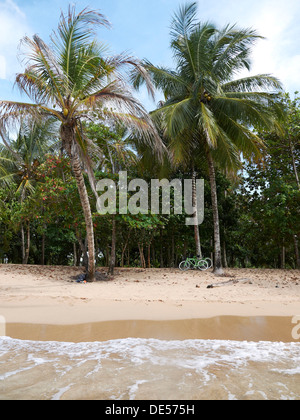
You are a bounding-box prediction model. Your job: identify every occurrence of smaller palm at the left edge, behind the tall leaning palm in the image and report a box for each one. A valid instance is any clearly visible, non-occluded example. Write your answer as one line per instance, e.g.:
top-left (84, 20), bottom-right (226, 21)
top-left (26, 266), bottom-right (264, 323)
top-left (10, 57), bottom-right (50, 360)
top-left (0, 119), bottom-right (57, 264)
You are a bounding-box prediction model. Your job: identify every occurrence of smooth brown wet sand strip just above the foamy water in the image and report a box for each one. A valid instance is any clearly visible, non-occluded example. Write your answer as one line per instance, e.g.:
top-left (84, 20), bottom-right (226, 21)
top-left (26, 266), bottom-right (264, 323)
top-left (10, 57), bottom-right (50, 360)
top-left (6, 316), bottom-right (300, 343)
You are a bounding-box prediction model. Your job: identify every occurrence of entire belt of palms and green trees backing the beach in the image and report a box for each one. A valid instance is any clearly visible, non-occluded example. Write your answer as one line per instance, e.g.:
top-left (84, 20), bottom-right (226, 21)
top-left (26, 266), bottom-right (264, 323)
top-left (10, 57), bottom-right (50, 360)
top-left (0, 3), bottom-right (300, 281)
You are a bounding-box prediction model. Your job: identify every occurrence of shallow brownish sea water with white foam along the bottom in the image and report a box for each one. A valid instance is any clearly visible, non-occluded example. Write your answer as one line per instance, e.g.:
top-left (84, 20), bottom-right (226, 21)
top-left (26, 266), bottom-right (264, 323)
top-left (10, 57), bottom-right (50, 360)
top-left (0, 338), bottom-right (300, 400)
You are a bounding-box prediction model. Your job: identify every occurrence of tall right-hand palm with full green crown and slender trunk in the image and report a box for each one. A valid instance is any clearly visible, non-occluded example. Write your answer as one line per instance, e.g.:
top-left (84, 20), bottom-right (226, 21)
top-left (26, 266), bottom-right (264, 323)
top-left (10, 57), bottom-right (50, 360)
top-left (135, 3), bottom-right (281, 274)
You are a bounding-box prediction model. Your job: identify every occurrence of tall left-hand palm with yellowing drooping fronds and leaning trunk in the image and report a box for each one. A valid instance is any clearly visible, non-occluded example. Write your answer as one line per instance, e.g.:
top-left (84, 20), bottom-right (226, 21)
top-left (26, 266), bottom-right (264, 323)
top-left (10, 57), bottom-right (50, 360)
top-left (0, 7), bottom-right (159, 281)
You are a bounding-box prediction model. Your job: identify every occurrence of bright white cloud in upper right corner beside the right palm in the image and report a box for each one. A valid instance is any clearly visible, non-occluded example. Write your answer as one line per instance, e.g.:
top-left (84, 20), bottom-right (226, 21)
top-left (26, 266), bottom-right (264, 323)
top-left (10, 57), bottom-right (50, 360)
top-left (203, 0), bottom-right (300, 93)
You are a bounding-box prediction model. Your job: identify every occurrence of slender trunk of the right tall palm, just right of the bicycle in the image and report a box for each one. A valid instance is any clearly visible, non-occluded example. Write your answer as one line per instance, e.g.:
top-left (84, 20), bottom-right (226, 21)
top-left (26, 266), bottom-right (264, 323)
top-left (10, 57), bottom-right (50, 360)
top-left (206, 150), bottom-right (223, 275)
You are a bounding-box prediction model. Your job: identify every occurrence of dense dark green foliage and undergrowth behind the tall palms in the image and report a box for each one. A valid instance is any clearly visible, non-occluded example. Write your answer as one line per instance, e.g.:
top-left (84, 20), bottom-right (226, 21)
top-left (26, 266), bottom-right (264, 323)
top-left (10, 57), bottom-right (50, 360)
top-left (0, 95), bottom-right (300, 268)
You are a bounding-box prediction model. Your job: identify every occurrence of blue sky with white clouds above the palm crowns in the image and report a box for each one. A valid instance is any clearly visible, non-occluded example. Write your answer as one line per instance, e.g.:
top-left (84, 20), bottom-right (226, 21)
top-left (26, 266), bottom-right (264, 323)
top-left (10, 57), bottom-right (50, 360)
top-left (0, 0), bottom-right (300, 109)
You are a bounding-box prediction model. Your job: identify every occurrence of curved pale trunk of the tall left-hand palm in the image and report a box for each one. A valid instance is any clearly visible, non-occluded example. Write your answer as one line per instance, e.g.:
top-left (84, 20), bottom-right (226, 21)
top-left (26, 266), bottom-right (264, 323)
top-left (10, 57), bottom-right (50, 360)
top-left (61, 126), bottom-right (96, 282)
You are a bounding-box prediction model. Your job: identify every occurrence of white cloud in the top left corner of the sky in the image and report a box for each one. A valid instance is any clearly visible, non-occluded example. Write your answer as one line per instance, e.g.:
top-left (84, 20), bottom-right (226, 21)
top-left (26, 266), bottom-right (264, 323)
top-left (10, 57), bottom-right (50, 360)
top-left (0, 0), bottom-right (30, 80)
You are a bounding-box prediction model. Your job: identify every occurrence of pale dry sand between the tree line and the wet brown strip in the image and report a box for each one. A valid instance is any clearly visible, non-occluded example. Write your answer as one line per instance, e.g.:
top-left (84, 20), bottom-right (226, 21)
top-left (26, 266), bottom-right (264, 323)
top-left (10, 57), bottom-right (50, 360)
top-left (0, 265), bottom-right (300, 325)
